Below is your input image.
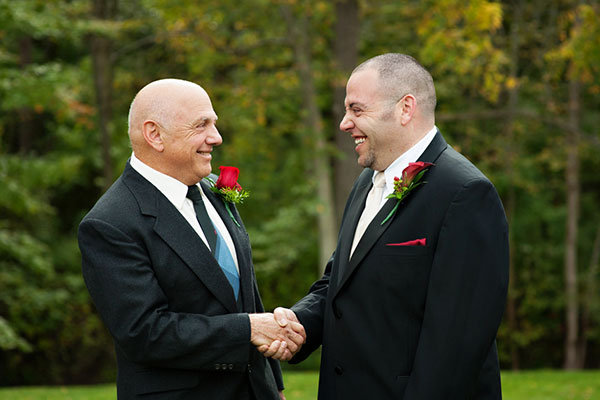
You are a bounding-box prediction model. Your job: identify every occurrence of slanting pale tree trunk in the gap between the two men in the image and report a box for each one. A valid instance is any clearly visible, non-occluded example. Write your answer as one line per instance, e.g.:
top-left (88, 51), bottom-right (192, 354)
top-left (282, 6), bottom-right (337, 274)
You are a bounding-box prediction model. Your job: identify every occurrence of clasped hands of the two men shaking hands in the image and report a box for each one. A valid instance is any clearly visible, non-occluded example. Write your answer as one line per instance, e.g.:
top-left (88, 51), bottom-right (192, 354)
top-left (249, 307), bottom-right (306, 361)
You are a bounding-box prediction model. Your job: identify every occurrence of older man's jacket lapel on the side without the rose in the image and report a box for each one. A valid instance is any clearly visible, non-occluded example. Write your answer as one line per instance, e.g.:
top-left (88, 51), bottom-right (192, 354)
top-left (123, 163), bottom-right (237, 312)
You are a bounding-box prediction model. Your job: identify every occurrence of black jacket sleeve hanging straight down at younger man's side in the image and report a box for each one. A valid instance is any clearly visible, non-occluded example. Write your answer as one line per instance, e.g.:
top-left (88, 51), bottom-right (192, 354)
top-left (404, 179), bottom-right (508, 400)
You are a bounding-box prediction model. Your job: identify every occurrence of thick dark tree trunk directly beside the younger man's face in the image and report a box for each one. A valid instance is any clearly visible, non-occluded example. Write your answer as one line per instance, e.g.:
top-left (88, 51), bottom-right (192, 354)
top-left (332, 0), bottom-right (362, 226)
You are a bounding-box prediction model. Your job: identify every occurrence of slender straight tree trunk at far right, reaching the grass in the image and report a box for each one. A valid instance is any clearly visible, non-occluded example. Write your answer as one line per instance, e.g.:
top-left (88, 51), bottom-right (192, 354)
top-left (564, 66), bottom-right (581, 369)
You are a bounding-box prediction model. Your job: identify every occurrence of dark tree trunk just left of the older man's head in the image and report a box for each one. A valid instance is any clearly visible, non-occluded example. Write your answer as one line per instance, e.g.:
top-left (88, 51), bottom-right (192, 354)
top-left (91, 0), bottom-right (117, 191)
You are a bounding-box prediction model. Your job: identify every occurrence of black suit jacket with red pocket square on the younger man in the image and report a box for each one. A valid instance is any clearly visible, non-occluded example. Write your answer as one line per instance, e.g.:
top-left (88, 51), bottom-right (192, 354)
top-left (292, 132), bottom-right (508, 400)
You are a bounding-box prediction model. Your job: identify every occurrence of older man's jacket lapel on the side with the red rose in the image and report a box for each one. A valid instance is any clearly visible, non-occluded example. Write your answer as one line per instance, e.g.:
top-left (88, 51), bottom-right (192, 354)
top-left (200, 179), bottom-right (255, 311)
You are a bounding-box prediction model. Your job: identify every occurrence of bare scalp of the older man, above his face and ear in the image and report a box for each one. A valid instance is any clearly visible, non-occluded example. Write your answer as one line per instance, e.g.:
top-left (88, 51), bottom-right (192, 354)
top-left (128, 79), bottom-right (208, 152)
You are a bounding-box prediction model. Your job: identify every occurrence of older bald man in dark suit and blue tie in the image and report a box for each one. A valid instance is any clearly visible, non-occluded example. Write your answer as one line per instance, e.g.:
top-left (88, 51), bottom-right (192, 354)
top-left (79, 79), bottom-right (305, 400)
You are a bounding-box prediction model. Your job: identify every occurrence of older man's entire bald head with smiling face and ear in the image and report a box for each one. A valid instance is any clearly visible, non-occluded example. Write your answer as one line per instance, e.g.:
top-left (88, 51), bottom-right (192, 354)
top-left (129, 79), bottom-right (222, 185)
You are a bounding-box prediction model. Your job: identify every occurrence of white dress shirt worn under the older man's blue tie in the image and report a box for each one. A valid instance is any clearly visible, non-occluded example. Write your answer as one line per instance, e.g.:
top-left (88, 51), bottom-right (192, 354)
top-left (129, 153), bottom-right (240, 272)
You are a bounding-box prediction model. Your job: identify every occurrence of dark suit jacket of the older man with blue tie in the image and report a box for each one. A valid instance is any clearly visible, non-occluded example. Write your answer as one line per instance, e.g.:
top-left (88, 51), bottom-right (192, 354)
top-left (79, 163), bottom-right (283, 400)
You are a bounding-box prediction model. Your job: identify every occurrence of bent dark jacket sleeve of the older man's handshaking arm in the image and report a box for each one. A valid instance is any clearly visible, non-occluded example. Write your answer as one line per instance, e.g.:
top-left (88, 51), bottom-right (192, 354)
top-left (79, 218), bottom-right (251, 371)
